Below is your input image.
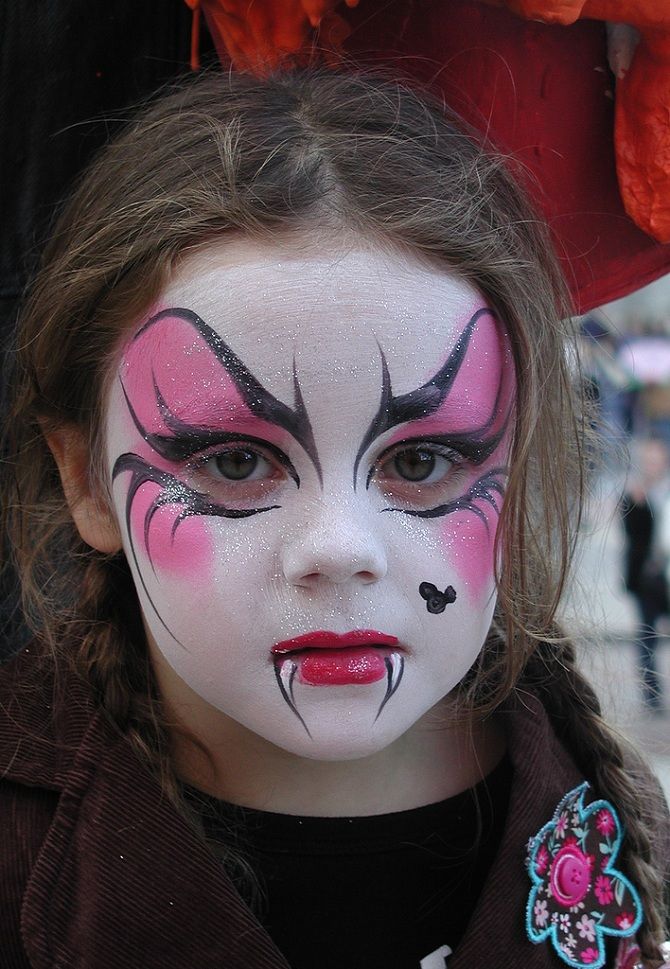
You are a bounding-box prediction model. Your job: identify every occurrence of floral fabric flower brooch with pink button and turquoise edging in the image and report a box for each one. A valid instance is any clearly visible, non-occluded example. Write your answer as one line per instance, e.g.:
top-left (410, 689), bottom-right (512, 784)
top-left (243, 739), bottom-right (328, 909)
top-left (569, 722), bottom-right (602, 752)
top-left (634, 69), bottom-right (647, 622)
top-left (526, 783), bottom-right (642, 969)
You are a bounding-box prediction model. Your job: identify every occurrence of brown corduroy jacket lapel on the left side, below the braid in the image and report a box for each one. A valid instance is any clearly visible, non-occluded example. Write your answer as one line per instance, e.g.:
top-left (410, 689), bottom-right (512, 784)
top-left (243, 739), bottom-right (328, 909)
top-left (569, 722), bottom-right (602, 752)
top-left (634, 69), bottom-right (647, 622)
top-left (22, 715), bottom-right (287, 969)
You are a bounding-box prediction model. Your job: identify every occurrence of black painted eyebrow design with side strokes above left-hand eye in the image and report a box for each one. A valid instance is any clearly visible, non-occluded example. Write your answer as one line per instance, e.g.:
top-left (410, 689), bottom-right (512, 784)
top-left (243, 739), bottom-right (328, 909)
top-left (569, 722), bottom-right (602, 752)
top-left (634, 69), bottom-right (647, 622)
top-left (121, 308), bottom-right (323, 482)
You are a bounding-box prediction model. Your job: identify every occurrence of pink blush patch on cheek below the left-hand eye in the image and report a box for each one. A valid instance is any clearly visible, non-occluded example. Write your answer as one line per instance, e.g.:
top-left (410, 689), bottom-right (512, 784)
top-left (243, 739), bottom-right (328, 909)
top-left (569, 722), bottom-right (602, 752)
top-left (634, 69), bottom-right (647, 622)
top-left (125, 483), bottom-right (214, 576)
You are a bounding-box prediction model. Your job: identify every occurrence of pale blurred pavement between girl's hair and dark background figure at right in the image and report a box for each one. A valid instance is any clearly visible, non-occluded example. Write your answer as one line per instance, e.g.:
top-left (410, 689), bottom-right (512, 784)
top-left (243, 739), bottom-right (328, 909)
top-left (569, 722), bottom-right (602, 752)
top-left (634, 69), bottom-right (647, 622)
top-left (562, 477), bottom-right (670, 803)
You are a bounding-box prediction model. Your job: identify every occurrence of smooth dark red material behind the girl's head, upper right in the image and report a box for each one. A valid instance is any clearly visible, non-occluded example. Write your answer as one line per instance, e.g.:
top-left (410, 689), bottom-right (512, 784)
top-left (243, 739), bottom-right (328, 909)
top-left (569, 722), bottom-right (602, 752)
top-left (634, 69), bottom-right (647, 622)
top-left (190, 0), bottom-right (670, 312)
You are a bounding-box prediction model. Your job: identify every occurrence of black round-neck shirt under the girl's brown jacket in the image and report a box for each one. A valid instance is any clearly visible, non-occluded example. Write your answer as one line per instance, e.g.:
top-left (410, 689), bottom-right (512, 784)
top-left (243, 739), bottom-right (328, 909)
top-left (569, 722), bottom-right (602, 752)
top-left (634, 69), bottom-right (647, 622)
top-left (188, 758), bottom-right (512, 969)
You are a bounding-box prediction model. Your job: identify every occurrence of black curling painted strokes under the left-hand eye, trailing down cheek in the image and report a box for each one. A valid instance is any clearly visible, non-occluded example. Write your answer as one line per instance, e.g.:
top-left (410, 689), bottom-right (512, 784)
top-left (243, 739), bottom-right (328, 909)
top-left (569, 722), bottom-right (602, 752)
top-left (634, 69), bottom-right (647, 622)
top-left (112, 453), bottom-right (279, 646)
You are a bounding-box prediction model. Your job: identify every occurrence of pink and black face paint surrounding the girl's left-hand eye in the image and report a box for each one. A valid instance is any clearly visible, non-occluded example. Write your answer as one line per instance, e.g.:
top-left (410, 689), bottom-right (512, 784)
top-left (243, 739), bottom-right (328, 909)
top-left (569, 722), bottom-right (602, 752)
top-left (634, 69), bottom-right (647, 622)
top-left (113, 309), bottom-right (318, 588)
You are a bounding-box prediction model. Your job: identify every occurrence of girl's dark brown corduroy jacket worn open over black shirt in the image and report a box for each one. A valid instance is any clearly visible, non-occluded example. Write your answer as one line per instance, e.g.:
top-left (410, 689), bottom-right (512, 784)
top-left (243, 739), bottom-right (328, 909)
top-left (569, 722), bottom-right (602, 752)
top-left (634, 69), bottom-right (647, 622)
top-left (0, 648), bottom-right (668, 969)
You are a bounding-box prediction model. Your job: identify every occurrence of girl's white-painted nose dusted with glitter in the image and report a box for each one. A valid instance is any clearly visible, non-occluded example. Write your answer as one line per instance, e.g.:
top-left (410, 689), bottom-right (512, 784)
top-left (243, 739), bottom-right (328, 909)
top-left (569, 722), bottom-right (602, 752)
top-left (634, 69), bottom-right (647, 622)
top-left (282, 506), bottom-right (387, 589)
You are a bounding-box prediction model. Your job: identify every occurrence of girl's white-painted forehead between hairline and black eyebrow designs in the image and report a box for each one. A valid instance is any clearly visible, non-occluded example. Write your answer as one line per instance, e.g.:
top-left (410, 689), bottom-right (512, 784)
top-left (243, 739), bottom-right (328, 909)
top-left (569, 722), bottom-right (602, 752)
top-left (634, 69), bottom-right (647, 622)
top-left (130, 239), bottom-right (494, 392)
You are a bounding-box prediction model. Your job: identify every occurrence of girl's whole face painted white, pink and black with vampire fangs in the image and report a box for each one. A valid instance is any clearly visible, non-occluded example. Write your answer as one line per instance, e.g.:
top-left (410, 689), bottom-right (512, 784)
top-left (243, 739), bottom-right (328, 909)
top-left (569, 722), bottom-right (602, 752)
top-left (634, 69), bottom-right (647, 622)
top-left (106, 240), bottom-right (514, 760)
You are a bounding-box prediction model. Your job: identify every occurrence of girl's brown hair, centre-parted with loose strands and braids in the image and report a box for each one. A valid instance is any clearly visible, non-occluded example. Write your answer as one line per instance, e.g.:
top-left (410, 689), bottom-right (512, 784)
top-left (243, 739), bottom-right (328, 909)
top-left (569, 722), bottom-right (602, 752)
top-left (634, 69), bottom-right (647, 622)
top-left (5, 71), bottom-right (662, 964)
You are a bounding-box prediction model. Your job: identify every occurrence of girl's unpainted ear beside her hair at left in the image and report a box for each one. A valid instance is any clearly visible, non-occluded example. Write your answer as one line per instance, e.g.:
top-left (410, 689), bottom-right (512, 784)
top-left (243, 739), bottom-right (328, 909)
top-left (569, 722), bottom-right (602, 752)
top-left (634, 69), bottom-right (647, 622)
top-left (46, 424), bottom-right (122, 554)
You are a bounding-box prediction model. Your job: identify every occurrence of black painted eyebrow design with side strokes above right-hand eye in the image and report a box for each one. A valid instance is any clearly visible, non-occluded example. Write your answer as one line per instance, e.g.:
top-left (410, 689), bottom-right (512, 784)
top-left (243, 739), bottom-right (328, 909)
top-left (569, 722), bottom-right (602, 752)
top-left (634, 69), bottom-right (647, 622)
top-left (354, 307), bottom-right (503, 488)
